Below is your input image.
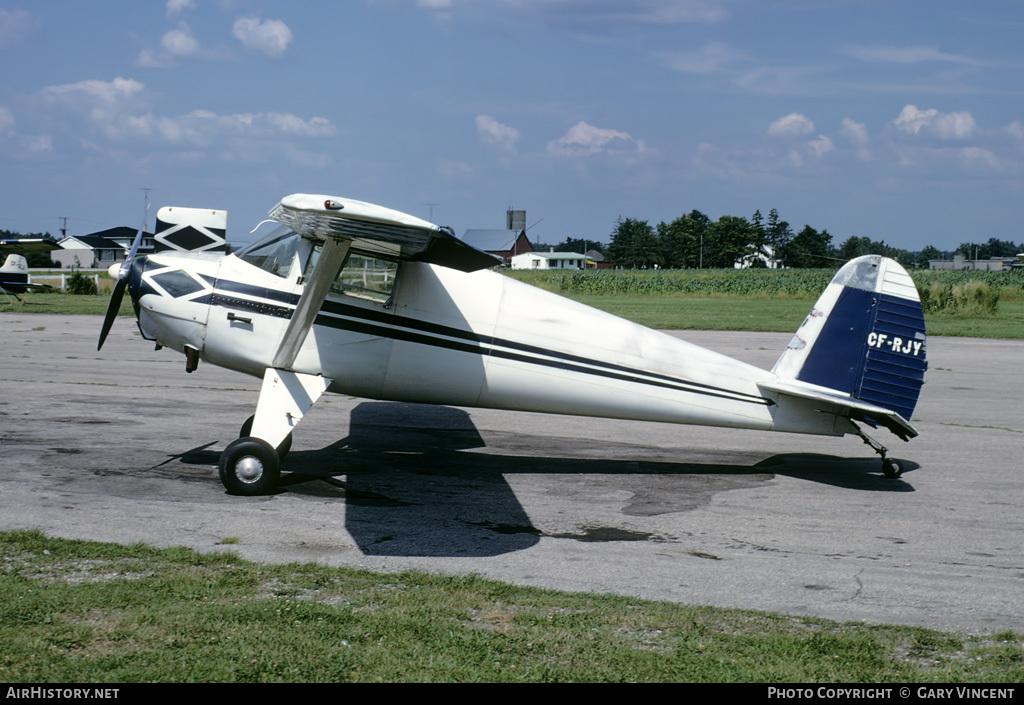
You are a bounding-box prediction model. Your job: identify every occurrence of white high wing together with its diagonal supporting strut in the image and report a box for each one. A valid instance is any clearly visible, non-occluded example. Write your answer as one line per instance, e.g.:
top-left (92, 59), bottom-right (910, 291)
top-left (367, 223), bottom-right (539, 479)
top-left (270, 194), bottom-right (501, 369)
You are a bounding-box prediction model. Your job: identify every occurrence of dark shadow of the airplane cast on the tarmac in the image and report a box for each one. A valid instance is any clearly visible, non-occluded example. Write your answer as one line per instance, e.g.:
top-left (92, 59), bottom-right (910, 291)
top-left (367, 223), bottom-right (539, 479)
top-left (179, 402), bottom-right (916, 557)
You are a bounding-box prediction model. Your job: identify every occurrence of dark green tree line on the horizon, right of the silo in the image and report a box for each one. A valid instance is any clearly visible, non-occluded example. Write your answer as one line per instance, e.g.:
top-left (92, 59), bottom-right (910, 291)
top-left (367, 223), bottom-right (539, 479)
top-left (540, 208), bottom-right (1024, 269)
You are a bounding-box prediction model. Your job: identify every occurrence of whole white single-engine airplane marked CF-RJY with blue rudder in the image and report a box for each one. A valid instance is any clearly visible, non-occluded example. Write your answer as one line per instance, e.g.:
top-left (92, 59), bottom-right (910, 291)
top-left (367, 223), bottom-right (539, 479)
top-left (99, 194), bottom-right (927, 495)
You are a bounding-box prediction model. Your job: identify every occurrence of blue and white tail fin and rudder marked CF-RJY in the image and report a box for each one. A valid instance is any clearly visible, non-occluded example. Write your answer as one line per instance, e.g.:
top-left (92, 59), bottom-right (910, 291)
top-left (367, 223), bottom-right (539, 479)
top-left (772, 255), bottom-right (928, 439)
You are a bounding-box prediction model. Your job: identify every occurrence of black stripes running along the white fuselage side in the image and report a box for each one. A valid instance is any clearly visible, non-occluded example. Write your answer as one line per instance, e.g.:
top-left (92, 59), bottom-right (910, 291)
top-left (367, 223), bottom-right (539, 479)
top-left (210, 280), bottom-right (774, 406)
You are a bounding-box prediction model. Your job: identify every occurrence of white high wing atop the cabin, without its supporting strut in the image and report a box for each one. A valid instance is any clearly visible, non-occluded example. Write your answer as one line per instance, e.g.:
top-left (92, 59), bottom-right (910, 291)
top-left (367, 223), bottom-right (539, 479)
top-left (270, 194), bottom-right (501, 272)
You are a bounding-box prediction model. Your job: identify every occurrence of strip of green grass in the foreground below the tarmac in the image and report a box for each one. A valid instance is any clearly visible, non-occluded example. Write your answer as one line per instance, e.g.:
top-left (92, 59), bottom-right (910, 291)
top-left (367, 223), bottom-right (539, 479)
top-left (0, 532), bottom-right (1024, 683)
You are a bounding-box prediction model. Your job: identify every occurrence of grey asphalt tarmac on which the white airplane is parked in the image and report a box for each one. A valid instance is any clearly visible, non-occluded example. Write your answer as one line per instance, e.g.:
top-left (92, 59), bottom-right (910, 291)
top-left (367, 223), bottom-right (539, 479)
top-left (0, 314), bottom-right (1024, 632)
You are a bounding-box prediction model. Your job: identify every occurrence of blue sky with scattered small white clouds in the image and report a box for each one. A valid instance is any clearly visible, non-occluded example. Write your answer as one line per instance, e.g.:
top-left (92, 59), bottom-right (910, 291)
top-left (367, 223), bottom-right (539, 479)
top-left (0, 0), bottom-right (1024, 250)
